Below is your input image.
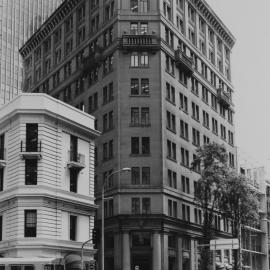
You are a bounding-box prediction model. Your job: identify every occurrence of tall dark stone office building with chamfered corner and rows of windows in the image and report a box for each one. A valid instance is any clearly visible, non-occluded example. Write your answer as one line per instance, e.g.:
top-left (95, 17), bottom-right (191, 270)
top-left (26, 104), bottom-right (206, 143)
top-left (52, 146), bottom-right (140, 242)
top-left (20, 0), bottom-right (236, 270)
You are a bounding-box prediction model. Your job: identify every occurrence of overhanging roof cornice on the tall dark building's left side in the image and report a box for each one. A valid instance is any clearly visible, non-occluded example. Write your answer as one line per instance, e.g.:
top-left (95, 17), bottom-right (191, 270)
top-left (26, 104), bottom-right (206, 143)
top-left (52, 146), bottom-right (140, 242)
top-left (19, 0), bottom-right (81, 57)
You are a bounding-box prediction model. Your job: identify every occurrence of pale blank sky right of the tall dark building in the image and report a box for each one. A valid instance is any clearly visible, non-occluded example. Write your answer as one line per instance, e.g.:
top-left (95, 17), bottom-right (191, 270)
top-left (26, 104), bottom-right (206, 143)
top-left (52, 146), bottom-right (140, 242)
top-left (207, 0), bottom-right (270, 171)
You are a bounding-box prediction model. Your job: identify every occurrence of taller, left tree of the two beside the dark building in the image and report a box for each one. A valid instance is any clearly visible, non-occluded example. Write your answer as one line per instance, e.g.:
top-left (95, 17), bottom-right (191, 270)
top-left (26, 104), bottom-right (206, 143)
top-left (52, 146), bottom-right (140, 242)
top-left (192, 142), bottom-right (229, 270)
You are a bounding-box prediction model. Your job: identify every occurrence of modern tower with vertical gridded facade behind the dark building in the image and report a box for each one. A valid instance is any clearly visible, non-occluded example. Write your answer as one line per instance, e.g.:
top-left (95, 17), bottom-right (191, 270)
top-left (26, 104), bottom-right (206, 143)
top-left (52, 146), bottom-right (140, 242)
top-left (0, 0), bottom-right (62, 106)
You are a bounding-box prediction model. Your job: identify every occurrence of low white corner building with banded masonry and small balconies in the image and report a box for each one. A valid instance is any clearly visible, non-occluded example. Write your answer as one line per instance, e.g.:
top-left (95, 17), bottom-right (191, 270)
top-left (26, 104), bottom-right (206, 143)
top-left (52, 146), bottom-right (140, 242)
top-left (0, 94), bottom-right (99, 269)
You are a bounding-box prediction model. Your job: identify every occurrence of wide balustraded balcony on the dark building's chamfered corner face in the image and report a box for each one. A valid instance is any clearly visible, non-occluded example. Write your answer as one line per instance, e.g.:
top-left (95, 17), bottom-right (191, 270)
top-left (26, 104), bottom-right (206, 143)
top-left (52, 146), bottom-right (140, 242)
top-left (122, 34), bottom-right (160, 52)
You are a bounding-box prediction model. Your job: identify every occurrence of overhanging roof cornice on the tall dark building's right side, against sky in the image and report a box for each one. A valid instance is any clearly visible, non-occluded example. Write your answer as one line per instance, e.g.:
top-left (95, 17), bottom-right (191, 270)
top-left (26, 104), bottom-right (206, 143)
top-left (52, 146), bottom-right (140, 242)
top-left (189, 0), bottom-right (236, 48)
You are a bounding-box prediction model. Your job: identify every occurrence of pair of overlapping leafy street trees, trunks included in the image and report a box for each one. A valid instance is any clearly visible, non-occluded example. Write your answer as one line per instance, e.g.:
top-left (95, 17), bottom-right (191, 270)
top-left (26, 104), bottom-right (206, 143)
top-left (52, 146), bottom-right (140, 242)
top-left (192, 142), bottom-right (259, 270)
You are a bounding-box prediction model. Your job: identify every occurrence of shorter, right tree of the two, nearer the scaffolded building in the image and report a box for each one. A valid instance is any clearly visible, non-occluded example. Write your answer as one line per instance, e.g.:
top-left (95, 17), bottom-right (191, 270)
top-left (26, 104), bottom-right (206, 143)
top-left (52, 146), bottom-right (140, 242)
top-left (219, 172), bottom-right (259, 270)
